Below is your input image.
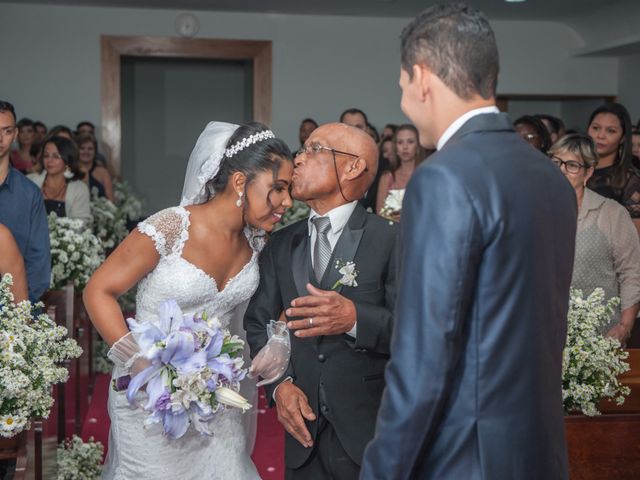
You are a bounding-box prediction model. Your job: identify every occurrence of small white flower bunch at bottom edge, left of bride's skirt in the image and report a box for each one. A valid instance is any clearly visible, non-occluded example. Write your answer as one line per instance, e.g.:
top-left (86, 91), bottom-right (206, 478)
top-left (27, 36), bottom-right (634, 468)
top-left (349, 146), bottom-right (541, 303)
top-left (56, 435), bottom-right (104, 480)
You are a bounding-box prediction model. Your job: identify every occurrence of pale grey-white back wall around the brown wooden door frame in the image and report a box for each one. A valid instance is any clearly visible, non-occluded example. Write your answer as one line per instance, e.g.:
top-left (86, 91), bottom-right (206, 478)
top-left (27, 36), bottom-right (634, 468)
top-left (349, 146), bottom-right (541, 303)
top-left (0, 3), bottom-right (618, 149)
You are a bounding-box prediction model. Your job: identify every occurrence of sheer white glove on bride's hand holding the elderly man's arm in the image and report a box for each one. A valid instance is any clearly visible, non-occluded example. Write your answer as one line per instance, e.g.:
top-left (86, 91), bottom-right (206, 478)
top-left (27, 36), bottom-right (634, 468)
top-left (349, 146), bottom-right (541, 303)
top-left (248, 320), bottom-right (291, 387)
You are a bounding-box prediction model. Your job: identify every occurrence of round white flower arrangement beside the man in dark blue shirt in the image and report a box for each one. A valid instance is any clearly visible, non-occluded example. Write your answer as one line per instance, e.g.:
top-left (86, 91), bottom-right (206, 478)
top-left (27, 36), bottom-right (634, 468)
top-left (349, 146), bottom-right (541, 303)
top-left (49, 212), bottom-right (104, 290)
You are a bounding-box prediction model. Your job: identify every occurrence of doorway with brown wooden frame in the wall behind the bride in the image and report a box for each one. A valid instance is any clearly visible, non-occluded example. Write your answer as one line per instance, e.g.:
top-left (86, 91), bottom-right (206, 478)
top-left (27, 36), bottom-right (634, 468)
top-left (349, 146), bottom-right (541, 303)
top-left (101, 36), bottom-right (272, 213)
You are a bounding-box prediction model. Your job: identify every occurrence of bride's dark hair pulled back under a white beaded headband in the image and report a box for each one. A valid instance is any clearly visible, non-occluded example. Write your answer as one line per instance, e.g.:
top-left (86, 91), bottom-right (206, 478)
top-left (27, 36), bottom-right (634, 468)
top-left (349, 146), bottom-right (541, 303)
top-left (207, 122), bottom-right (293, 202)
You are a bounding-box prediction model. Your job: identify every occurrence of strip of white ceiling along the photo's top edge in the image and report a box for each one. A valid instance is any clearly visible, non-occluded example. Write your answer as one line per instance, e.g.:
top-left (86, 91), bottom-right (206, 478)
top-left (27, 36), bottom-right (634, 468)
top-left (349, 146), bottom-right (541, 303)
top-left (0, 0), bottom-right (624, 22)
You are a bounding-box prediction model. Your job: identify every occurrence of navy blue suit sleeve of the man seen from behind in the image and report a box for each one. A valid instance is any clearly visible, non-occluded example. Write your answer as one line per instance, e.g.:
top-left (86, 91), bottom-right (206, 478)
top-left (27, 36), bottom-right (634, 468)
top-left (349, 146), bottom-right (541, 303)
top-left (361, 164), bottom-right (482, 479)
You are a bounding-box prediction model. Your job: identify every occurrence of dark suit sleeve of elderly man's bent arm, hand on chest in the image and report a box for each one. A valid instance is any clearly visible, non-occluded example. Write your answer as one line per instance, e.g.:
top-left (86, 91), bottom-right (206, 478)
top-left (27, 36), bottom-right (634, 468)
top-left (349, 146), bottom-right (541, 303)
top-left (355, 238), bottom-right (397, 355)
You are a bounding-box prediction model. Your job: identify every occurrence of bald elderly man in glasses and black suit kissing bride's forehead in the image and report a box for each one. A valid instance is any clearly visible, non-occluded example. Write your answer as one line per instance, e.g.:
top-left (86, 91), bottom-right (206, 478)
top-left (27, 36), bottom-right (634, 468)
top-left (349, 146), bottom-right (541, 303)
top-left (245, 123), bottom-right (396, 480)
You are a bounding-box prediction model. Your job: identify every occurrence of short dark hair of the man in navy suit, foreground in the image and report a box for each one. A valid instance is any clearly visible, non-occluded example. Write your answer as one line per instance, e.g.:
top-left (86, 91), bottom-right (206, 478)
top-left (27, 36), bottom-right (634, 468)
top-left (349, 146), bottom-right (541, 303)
top-left (400, 3), bottom-right (500, 100)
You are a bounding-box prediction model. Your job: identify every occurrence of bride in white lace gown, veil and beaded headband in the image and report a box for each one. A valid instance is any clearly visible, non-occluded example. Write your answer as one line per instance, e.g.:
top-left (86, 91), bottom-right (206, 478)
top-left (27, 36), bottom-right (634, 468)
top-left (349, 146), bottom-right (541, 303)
top-left (84, 122), bottom-right (293, 480)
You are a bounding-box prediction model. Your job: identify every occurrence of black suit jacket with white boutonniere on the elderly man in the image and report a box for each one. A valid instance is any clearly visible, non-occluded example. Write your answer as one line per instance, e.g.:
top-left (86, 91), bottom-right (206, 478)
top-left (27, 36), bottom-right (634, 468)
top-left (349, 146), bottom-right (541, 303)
top-left (244, 205), bottom-right (396, 468)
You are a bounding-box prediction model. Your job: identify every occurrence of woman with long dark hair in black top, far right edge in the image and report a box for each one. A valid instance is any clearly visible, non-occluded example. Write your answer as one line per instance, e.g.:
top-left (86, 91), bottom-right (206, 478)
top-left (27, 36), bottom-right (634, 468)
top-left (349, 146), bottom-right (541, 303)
top-left (587, 103), bottom-right (640, 231)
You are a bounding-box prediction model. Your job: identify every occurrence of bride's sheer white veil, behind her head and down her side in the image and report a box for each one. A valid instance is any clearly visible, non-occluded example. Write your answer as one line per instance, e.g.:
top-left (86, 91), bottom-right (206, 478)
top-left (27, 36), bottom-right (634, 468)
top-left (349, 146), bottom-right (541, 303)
top-left (180, 122), bottom-right (258, 453)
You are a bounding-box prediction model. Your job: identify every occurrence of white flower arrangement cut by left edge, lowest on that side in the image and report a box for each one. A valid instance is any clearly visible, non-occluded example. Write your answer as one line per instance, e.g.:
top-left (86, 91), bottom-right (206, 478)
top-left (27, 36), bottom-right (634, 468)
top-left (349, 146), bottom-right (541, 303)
top-left (0, 274), bottom-right (82, 437)
